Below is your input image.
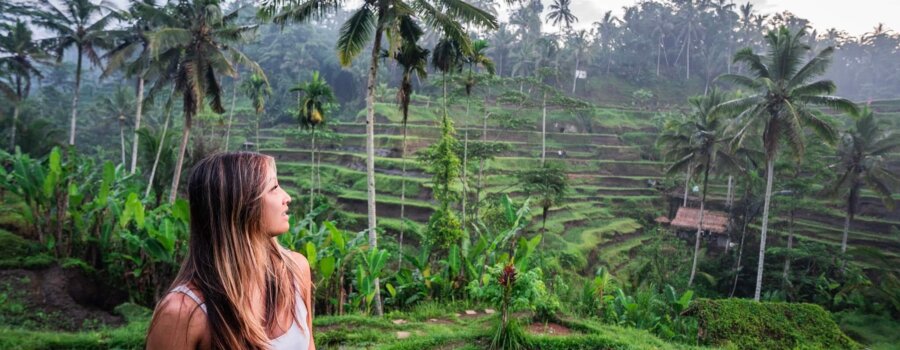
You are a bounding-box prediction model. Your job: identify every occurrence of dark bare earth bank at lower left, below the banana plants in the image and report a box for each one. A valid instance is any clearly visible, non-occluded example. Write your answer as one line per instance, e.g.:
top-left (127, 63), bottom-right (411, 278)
top-left (0, 266), bottom-right (127, 331)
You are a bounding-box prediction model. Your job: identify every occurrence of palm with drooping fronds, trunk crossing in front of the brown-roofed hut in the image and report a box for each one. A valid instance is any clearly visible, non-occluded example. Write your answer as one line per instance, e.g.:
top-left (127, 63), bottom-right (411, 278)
top-left (667, 89), bottom-right (738, 287)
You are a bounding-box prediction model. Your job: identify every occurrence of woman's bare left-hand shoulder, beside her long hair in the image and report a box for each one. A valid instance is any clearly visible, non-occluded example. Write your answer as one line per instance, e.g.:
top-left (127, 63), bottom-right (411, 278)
top-left (147, 293), bottom-right (209, 349)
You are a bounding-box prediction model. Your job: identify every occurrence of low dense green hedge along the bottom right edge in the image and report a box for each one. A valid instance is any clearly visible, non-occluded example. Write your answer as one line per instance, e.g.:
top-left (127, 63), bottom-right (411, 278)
top-left (688, 299), bottom-right (860, 349)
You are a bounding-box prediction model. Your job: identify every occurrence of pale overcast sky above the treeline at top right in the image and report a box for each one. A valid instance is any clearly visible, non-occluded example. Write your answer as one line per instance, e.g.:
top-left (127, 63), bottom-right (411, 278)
top-left (543, 0), bottom-right (900, 36)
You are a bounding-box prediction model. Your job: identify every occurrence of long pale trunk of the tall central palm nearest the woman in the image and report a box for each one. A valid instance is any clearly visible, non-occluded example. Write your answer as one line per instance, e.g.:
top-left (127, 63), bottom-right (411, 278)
top-left (366, 28), bottom-right (384, 316)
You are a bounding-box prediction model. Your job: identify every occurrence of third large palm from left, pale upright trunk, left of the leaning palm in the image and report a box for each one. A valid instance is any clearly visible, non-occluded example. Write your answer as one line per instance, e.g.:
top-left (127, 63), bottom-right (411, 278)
top-left (101, 0), bottom-right (167, 173)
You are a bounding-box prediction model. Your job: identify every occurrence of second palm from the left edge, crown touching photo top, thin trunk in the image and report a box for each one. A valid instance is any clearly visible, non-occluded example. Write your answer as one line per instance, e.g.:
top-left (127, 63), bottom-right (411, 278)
top-left (32, 0), bottom-right (121, 146)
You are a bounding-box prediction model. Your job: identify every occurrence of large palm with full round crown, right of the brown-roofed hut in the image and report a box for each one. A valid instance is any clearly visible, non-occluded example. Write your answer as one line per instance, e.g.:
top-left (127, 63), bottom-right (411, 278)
top-left (716, 26), bottom-right (856, 301)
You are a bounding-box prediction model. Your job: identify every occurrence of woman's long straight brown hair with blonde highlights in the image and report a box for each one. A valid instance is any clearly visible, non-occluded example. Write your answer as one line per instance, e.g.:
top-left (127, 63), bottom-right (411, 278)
top-left (151, 152), bottom-right (306, 349)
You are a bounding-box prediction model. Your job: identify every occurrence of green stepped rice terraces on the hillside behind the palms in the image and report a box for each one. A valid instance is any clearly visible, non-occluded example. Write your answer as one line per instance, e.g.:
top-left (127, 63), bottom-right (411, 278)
top-left (250, 103), bottom-right (900, 271)
